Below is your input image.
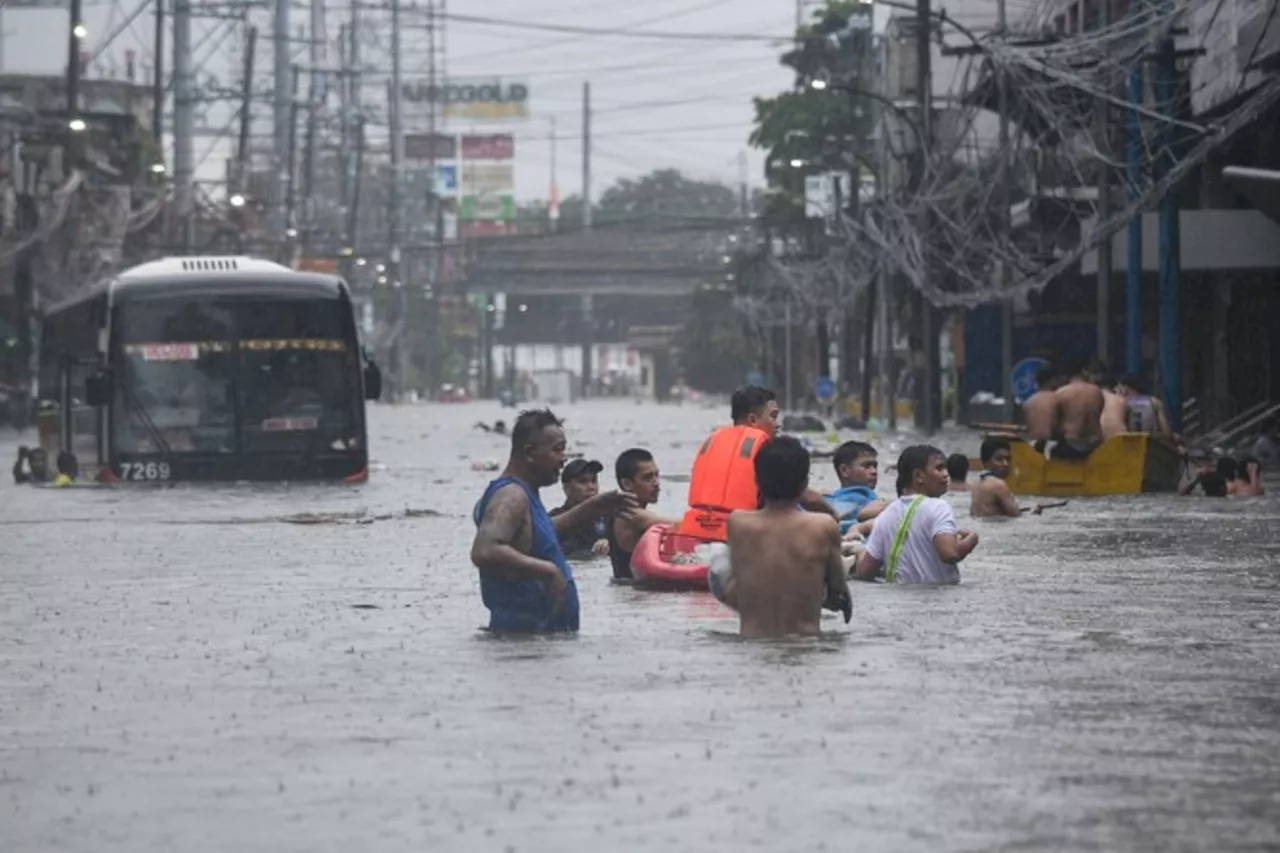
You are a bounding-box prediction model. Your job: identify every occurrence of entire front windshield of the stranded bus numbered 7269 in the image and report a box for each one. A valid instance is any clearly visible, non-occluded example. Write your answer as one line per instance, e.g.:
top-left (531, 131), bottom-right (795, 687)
top-left (115, 297), bottom-right (362, 453)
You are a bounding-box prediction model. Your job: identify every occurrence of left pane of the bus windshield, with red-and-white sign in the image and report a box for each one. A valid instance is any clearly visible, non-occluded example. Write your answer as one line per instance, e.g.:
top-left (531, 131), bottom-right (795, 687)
top-left (113, 301), bottom-right (236, 453)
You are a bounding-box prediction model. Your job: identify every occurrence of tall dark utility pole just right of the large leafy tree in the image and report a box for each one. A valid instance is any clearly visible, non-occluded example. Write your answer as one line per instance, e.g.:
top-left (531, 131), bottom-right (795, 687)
top-left (915, 0), bottom-right (942, 434)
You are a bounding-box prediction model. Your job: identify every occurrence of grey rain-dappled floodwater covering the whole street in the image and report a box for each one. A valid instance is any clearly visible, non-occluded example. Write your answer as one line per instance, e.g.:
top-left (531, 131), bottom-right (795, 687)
top-left (0, 402), bottom-right (1280, 853)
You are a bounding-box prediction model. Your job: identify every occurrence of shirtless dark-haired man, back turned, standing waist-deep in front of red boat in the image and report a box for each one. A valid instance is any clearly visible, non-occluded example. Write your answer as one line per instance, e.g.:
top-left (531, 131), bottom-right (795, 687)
top-left (724, 437), bottom-right (852, 637)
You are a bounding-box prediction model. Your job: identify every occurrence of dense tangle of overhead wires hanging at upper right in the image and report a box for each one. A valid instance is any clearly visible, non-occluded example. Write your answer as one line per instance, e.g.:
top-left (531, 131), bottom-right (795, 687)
top-left (819, 0), bottom-right (1280, 307)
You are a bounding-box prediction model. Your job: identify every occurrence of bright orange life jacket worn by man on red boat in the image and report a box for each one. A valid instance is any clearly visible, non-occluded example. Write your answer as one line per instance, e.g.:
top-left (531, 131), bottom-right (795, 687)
top-left (678, 427), bottom-right (769, 542)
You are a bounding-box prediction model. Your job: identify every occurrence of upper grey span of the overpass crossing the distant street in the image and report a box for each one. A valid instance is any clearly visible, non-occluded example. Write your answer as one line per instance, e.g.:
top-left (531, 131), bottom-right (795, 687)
top-left (465, 218), bottom-right (746, 298)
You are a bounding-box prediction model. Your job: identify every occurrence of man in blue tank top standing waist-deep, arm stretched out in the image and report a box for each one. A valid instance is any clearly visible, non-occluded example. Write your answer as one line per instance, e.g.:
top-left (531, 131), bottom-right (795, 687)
top-left (471, 409), bottom-right (634, 633)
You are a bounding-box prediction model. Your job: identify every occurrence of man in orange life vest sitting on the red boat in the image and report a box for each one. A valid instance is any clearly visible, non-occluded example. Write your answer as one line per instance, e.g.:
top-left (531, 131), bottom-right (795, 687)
top-left (678, 386), bottom-right (835, 542)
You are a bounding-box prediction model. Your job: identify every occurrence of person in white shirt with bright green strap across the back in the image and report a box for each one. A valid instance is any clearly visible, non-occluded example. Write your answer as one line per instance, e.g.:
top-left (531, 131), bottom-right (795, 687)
top-left (854, 444), bottom-right (978, 584)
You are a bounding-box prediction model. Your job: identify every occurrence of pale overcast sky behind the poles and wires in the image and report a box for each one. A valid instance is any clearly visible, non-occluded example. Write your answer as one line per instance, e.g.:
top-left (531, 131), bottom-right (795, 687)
top-left (4, 0), bottom-right (1003, 200)
